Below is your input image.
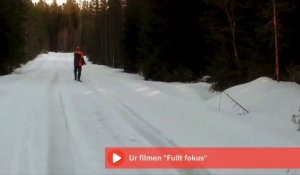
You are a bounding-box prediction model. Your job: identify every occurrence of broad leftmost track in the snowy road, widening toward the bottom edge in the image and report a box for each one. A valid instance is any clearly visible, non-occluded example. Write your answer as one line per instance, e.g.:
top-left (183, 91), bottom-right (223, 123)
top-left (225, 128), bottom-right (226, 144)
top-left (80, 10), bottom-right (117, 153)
top-left (47, 70), bottom-right (74, 174)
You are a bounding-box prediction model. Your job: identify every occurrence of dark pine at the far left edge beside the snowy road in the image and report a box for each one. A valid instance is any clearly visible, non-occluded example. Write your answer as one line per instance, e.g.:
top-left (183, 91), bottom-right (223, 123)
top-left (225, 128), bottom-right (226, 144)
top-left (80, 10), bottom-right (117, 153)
top-left (0, 0), bottom-right (25, 75)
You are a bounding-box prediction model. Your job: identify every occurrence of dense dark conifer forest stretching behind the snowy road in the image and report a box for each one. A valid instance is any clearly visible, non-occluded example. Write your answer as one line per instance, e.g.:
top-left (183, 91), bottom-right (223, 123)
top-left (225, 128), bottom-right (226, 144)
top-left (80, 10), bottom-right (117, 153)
top-left (0, 0), bottom-right (300, 90)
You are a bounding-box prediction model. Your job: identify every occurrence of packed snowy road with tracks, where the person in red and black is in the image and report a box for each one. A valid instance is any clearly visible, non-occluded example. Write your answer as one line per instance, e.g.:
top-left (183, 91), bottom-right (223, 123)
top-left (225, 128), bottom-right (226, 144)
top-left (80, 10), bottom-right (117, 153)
top-left (0, 53), bottom-right (202, 174)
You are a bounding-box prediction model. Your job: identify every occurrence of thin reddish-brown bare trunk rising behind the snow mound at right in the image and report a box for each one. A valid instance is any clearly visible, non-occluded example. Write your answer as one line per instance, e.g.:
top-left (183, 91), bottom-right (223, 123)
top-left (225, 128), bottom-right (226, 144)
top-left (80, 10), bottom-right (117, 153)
top-left (272, 0), bottom-right (280, 82)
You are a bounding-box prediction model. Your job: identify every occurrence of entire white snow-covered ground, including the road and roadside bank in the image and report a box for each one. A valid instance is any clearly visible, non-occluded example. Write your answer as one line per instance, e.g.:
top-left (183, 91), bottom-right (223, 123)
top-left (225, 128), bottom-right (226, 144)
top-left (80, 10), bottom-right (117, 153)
top-left (0, 53), bottom-right (300, 175)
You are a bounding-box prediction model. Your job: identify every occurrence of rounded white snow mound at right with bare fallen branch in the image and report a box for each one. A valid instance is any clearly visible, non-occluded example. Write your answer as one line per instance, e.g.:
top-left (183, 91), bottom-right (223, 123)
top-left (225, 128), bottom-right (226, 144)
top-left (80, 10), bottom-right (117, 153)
top-left (207, 77), bottom-right (300, 138)
